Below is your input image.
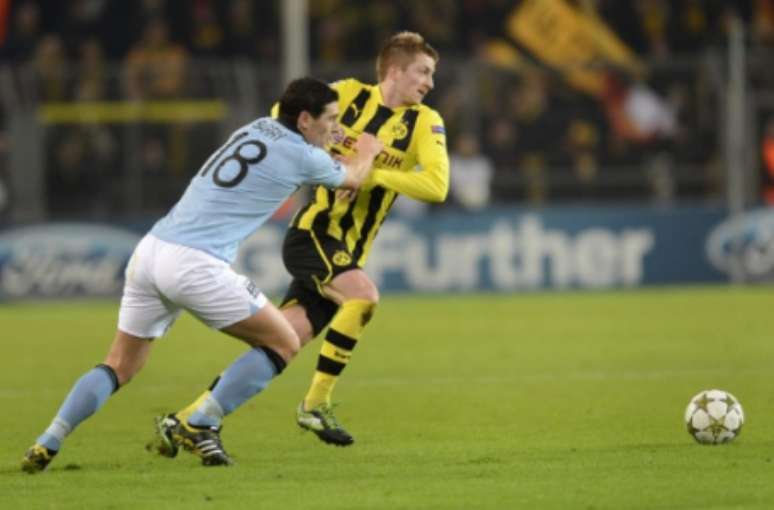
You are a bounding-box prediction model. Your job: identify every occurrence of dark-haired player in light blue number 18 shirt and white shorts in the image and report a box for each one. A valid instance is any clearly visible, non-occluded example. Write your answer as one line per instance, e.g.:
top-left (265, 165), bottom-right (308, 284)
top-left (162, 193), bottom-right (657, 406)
top-left (22, 78), bottom-right (382, 473)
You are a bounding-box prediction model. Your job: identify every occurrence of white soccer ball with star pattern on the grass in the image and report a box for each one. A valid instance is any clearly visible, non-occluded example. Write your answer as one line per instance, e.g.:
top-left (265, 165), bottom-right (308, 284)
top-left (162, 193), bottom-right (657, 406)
top-left (685, 390), bottom-right (744, 444)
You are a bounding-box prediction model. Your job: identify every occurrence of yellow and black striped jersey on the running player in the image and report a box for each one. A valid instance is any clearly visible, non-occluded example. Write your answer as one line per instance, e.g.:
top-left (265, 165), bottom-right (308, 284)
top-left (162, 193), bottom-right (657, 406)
top-left (291, 79), bottom-right (449, 267)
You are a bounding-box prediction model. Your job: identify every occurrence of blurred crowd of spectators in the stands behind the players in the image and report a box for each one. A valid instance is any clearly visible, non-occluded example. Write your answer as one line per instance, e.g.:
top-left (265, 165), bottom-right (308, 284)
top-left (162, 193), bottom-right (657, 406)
top-left (0, 0), bottom-right (774, 221)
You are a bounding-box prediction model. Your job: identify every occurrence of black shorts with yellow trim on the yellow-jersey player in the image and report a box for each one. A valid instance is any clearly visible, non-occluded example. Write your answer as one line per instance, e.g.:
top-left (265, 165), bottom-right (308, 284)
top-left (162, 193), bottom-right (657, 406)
top-left (280, 227), bottom-right (359, 336)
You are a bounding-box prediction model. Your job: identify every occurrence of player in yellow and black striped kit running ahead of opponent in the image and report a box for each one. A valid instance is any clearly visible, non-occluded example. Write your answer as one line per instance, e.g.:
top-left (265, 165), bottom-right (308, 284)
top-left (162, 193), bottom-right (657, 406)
top-left (159, 32), bottom-right (449, 453)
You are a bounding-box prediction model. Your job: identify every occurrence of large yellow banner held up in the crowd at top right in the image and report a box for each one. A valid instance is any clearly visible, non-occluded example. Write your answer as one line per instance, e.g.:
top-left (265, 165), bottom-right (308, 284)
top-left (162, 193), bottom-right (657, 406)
top-left (507, 0), bottom-right (641, 94)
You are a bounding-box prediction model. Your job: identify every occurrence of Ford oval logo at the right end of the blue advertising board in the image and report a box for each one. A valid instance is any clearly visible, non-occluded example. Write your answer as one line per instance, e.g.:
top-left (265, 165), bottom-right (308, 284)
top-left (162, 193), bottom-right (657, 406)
top-left (706, 209), bottom-right (774, 280)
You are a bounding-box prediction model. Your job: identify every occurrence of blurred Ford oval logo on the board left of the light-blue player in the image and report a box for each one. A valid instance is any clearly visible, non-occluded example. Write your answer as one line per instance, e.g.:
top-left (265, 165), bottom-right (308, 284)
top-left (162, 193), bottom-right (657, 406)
top-left (0, 223), bottom-right (140, 299)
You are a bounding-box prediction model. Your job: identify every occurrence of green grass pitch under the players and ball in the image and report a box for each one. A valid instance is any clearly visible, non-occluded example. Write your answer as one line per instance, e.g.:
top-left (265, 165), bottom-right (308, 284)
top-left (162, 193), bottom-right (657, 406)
top-left (0, 287), bottom-right (774, 510)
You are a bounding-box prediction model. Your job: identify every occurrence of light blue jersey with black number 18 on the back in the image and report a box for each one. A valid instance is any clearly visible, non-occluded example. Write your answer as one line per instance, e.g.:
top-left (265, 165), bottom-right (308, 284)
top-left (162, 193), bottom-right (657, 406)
top-left (150, 117), bottom-right (345, 263)
